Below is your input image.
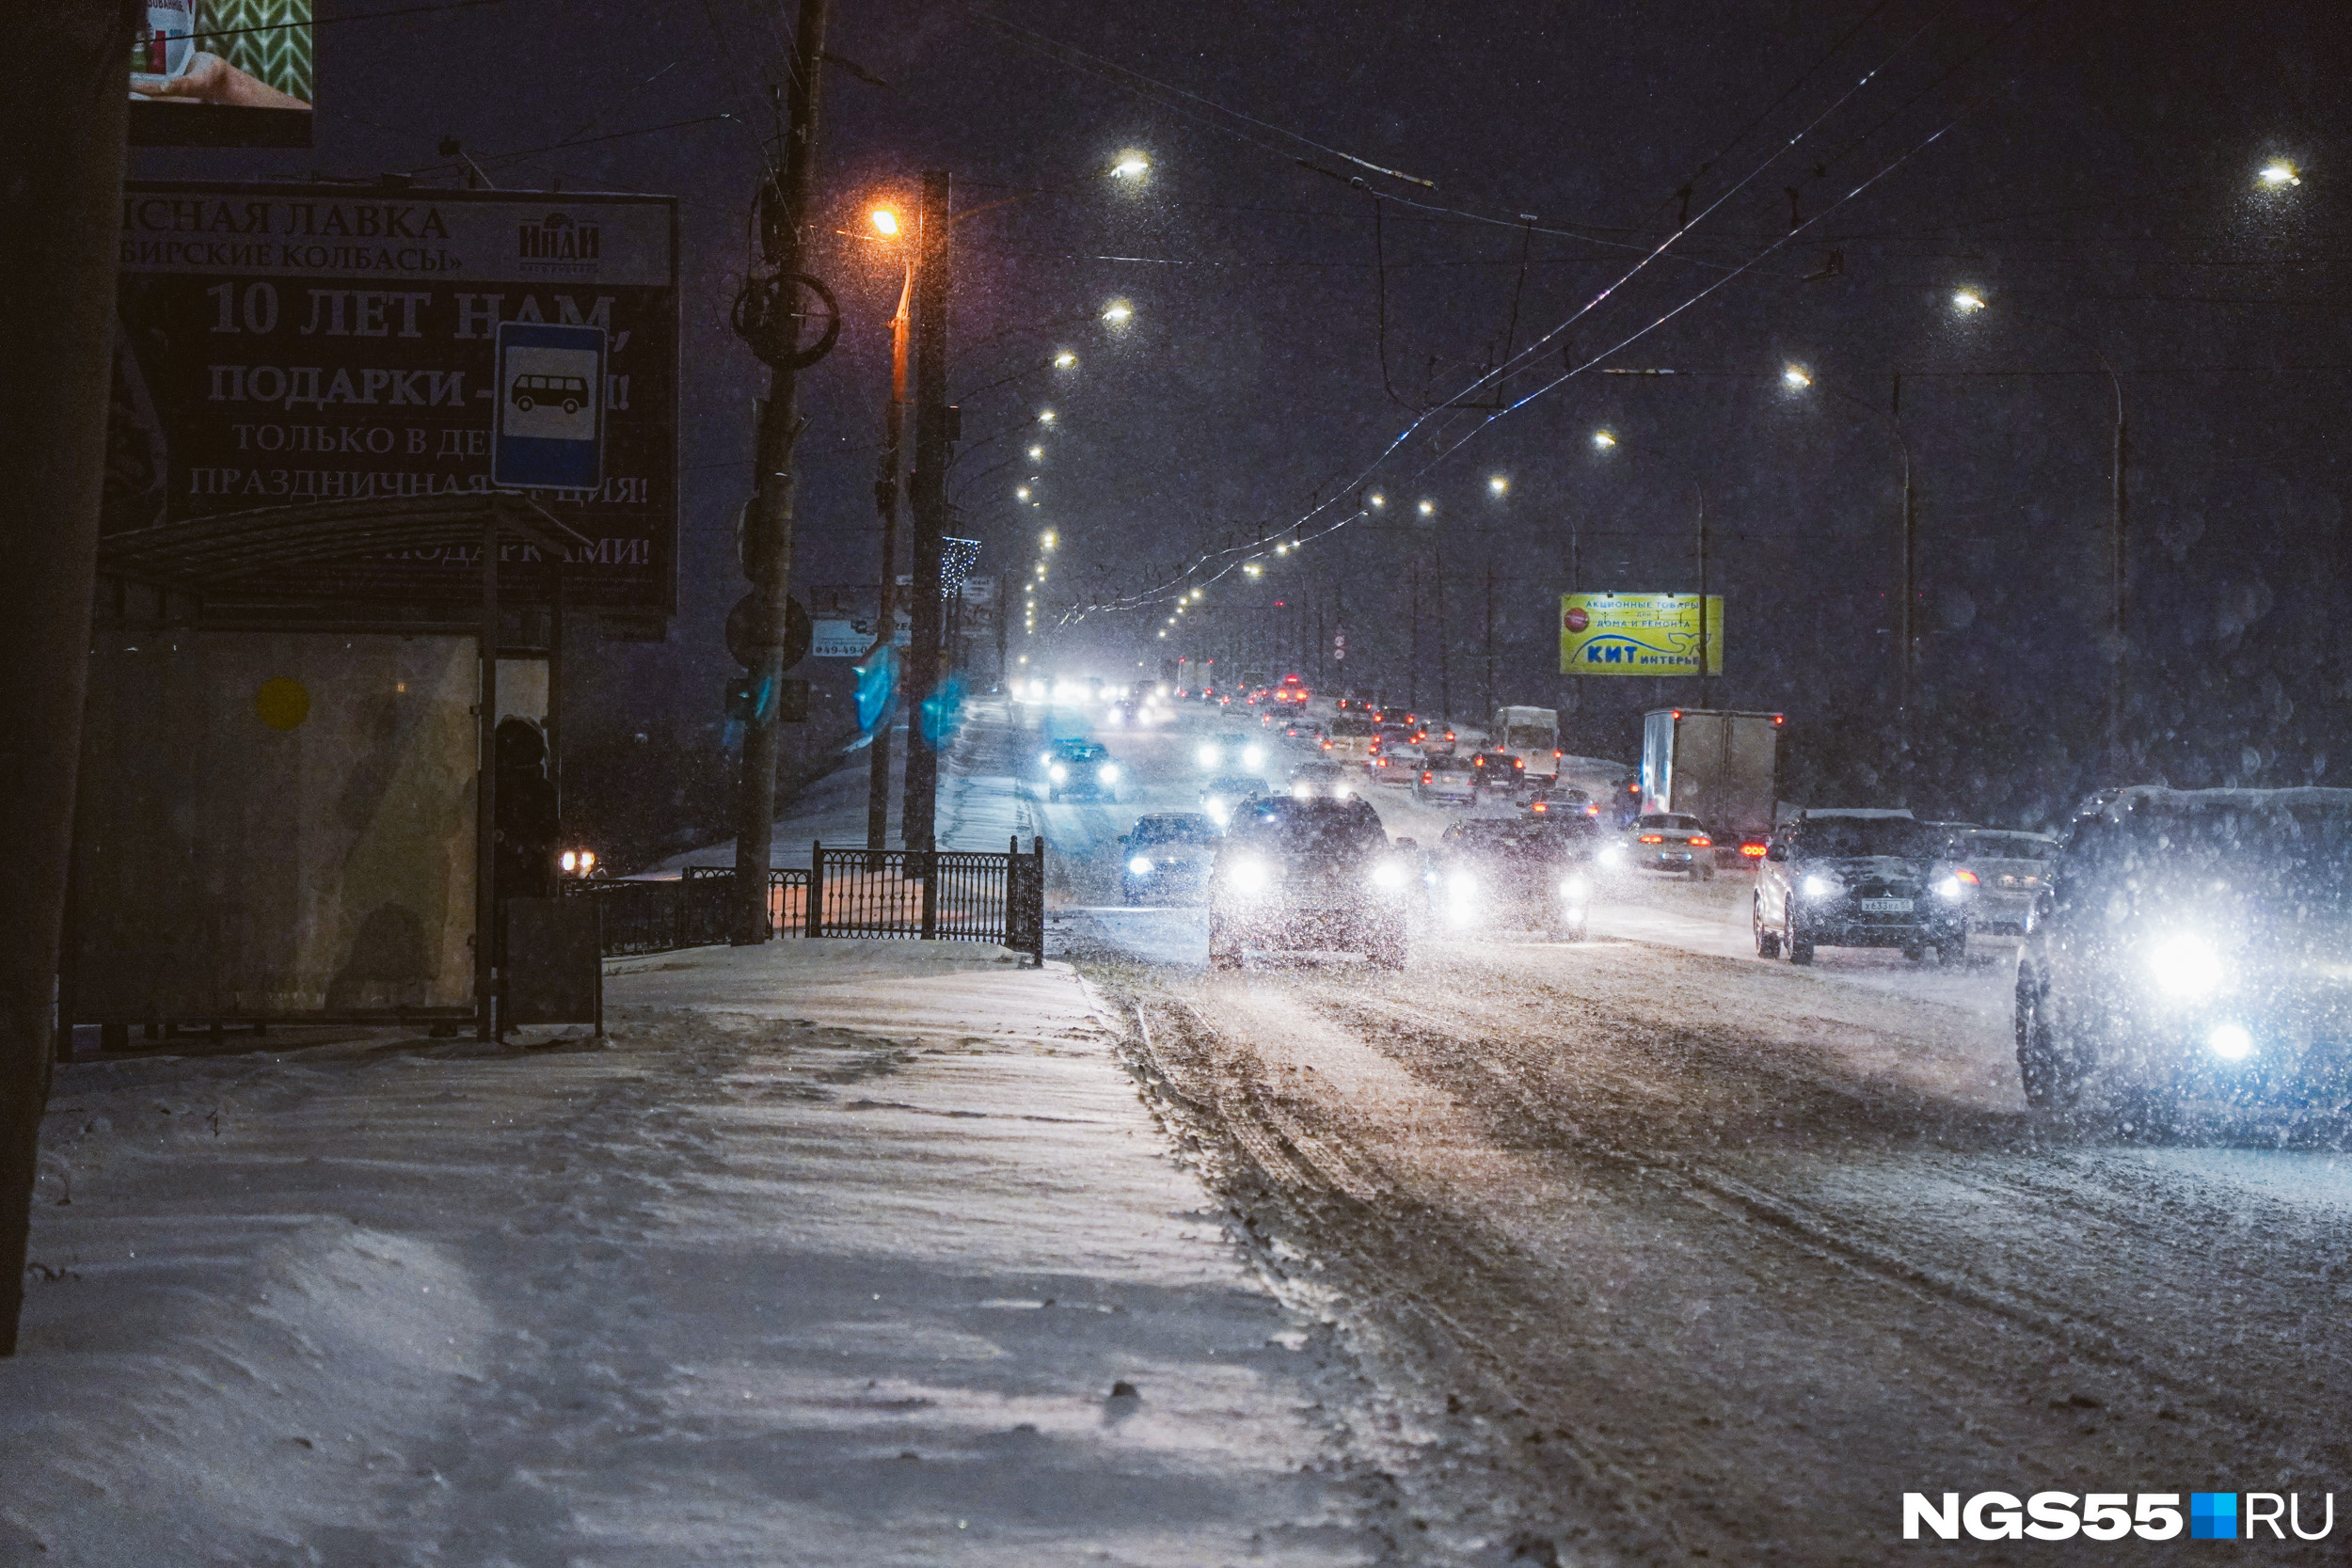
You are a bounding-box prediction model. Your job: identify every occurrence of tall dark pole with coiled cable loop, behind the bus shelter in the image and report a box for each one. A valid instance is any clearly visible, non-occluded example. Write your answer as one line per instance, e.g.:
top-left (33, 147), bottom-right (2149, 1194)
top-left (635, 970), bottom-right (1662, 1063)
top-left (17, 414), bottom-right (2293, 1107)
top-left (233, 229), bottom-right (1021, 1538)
top-left (732, 0), bottom-right (831, 945)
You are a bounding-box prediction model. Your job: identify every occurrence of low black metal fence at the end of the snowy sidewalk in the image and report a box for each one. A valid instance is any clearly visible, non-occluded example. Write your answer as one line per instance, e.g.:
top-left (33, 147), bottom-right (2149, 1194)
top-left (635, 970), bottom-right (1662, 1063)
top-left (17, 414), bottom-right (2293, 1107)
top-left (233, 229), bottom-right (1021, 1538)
top-left (564, 839), bottom-right (1044, 964)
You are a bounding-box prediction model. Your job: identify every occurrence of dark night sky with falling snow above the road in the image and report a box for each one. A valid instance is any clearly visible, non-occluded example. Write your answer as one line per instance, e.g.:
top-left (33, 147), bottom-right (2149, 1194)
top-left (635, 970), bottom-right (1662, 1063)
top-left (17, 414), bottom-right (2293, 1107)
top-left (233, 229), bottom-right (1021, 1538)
top-left (132, 0), bottom-right (2352, 846)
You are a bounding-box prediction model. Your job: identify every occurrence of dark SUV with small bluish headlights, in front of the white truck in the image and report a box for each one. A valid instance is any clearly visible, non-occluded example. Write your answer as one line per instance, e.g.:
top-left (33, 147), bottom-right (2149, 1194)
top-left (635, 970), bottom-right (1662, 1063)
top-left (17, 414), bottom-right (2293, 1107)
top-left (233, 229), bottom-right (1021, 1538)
top-left (1759, 809), bottom-right (1969, 964)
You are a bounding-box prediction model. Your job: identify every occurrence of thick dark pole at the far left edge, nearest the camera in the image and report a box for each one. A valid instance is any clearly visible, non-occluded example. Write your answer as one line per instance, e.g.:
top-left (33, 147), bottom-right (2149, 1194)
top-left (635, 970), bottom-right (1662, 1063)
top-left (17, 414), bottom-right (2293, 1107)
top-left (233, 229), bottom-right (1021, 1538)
top-left (0, 2), bottom-right (146, 1356)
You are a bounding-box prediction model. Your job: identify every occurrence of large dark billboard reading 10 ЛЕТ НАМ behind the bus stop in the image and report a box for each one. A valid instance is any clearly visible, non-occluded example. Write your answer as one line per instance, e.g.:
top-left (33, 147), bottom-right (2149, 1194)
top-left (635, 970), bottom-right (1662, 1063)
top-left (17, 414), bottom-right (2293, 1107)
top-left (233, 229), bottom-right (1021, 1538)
top-left (103, 183), bottom-right (677, 616)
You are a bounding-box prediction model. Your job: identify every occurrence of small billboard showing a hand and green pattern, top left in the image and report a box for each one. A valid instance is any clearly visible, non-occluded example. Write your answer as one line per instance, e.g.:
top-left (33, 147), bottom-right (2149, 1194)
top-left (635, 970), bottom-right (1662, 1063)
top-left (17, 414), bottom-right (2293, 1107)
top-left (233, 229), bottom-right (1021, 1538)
top-left (130, 0), bottom-right (318, 148)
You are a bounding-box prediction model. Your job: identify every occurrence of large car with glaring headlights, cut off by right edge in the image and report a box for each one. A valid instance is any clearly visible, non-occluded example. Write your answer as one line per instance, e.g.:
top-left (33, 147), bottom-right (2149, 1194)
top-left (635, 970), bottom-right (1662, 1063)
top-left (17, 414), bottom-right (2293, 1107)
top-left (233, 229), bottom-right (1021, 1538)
top-left (2013, 785), bottom-right (2352, 1133)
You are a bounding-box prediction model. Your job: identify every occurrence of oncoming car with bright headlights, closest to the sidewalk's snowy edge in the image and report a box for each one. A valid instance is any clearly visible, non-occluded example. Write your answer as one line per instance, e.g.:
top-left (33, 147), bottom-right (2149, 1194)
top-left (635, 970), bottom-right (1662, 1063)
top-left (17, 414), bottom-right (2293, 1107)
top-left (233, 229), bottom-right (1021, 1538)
top-left (1209, 797), bottom-right (1414, 969)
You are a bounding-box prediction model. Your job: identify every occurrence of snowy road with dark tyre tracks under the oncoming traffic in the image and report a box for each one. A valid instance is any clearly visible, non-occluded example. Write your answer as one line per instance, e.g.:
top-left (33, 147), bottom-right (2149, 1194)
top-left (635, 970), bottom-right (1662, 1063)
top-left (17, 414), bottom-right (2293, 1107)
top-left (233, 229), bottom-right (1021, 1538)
top-left (1033, 700), bottom-right (2352, 1563)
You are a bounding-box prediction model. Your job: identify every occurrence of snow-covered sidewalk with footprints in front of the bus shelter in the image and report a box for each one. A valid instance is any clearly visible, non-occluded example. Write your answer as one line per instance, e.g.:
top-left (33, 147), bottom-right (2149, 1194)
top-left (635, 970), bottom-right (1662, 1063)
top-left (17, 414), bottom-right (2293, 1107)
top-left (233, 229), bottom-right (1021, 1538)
top-left (0, 941), bottom-right (1378, 1568)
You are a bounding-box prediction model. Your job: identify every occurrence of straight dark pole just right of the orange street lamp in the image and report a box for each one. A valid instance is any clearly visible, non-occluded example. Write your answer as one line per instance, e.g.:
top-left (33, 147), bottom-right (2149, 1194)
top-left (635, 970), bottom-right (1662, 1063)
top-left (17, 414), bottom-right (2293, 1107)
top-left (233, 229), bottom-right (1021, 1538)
top-left (898, 169), bottom-right (953, 851)
